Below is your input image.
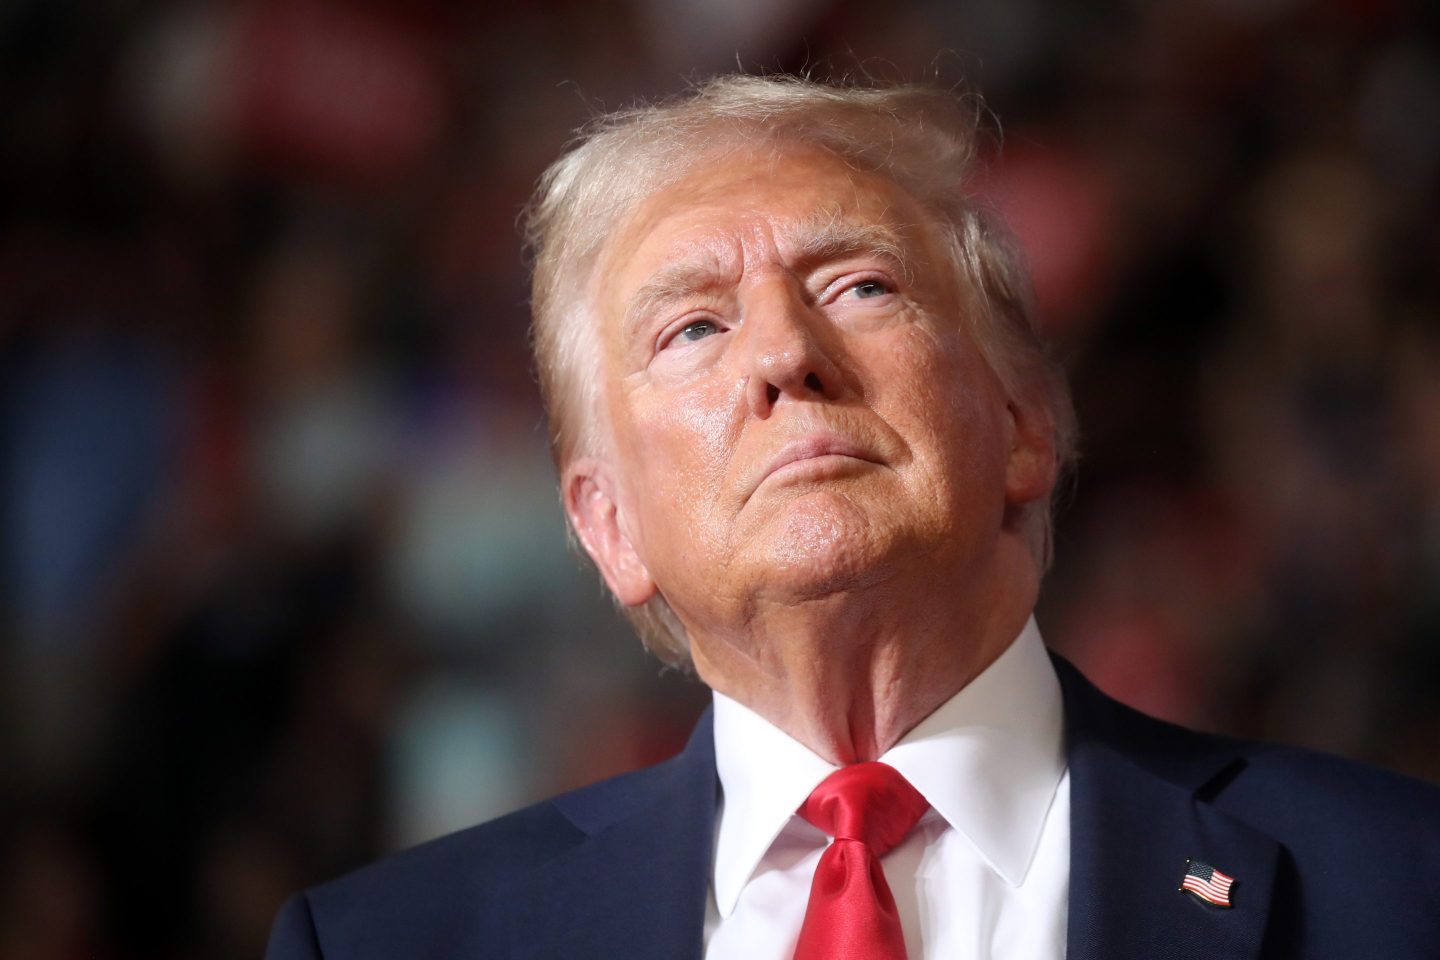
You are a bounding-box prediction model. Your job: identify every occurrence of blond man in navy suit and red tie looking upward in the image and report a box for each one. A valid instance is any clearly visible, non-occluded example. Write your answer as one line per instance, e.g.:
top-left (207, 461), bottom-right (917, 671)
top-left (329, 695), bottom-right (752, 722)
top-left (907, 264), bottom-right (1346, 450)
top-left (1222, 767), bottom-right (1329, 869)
top-left (269, 78), bottom-right (1440, 960)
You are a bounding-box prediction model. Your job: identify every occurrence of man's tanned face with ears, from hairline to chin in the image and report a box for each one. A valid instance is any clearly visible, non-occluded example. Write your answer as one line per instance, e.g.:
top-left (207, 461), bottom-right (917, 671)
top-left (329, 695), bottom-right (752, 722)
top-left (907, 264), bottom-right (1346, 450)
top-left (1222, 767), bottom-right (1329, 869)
top-left (566, 150), bottom-right (1048, 636)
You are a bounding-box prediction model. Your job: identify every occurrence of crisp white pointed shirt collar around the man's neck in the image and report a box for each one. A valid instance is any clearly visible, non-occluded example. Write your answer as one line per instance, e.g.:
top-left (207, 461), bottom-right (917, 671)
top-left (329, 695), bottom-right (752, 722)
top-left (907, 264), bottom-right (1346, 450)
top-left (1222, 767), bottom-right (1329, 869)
top-left (713, 617), bottom-right (1066, 917)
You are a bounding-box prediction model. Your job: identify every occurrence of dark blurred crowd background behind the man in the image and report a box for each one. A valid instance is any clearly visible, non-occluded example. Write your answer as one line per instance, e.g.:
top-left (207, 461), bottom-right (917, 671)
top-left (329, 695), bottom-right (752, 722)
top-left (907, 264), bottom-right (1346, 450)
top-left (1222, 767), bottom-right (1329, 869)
top-left (0, 0), bottom-right (1440, 960)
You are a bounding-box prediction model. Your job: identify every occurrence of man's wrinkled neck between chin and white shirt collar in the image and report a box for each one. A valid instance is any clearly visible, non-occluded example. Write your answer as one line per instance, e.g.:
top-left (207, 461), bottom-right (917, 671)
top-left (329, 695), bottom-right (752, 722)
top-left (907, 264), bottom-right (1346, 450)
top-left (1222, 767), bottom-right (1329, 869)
top-left (691, 552), bottom-right (1038, 766)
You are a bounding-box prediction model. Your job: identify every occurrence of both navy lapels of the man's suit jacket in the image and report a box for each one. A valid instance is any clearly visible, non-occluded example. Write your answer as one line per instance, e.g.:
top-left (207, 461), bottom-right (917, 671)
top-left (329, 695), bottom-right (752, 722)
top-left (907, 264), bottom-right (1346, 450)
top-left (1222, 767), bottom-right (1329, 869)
top-left (511, 658), bottom-right (1283, 960)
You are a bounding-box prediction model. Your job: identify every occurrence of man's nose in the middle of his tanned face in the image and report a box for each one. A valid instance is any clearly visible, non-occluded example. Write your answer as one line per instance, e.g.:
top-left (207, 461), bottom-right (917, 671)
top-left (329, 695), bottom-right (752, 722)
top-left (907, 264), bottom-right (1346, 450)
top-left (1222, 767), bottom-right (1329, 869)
top-left (742, 281), bottom-right (844, 420)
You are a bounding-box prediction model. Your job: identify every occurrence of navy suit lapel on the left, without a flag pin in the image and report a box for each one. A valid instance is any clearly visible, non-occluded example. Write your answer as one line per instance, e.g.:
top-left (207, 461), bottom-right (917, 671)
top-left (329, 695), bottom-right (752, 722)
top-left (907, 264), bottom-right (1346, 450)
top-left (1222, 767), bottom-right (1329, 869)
top-left (513, 711), bottom-right (717, 960)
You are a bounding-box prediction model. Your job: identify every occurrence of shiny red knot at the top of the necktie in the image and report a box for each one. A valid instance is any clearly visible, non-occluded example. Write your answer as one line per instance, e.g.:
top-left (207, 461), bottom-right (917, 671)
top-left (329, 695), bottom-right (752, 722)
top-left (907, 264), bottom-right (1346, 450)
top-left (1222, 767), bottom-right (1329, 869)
top-left (799, 760), bottom-right (930, 856)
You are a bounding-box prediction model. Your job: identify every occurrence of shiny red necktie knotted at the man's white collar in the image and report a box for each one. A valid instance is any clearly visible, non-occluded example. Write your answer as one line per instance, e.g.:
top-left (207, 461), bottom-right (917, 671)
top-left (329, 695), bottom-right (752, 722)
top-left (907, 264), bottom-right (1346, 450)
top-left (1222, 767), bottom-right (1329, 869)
top-left (795, 760), bottom-right (930, 960)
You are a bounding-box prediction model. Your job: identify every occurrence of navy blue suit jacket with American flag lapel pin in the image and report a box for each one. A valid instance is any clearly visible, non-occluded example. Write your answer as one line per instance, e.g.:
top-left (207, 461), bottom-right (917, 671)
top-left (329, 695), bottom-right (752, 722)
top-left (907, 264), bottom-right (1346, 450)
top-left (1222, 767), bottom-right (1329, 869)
top-left (266, 661), bottom-right (1440, 960)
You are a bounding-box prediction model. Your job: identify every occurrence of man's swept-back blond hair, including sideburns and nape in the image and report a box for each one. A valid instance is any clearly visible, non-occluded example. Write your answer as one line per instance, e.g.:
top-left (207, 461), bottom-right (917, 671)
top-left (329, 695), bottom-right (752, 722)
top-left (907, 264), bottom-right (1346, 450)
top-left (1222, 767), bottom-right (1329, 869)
top-left (524, 75), bottom-right (1076, 668)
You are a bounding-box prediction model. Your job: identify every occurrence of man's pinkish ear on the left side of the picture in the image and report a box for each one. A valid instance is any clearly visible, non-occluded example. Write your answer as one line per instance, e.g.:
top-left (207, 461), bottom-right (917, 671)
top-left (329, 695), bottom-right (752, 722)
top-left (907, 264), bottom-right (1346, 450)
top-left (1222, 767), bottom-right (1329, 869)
top-left (563, 456), bottom-right (658, 606)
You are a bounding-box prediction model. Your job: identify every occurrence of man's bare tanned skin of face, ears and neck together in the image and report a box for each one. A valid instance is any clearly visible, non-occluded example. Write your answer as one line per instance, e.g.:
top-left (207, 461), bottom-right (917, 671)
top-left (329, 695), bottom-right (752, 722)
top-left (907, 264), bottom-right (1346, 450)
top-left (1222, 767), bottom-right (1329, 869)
top-left (563, 150), bottom-right (1054, 763)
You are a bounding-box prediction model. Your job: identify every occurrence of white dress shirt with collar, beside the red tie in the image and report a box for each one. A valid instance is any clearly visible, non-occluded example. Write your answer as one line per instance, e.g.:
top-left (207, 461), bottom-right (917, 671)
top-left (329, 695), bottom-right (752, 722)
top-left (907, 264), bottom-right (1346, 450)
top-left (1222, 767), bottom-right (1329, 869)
top-left (706, 619), bottom-right (1070, 960)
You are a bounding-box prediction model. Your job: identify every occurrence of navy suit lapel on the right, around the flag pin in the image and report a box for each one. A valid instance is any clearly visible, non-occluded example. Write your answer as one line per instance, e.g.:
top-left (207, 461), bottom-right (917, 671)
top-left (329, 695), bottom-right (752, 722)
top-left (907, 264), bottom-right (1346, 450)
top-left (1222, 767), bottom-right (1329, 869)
top-left (1057, 662), bottom-right (1280, 960)
